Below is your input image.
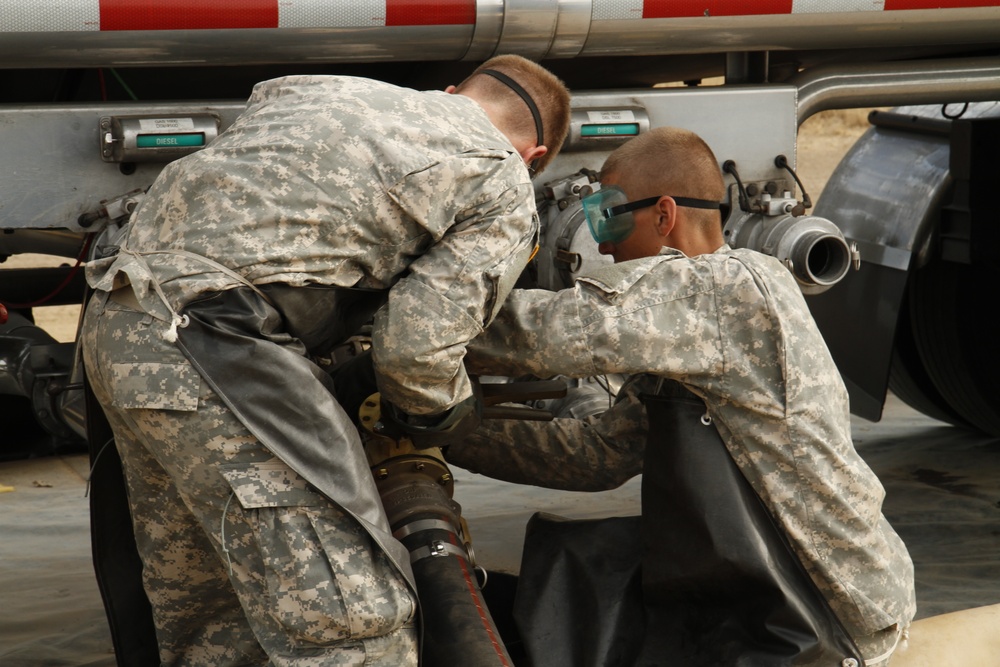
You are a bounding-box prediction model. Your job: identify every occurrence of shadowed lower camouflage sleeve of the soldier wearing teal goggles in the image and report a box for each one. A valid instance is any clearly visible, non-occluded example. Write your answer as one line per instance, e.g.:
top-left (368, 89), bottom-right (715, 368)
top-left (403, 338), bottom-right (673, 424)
top-left (447, 376), bottom-right (652, 491)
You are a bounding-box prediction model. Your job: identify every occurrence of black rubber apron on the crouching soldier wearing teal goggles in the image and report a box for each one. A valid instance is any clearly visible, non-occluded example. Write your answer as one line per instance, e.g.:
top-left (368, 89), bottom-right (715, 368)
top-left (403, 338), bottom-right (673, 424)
top-left (514, 396), bottom-right (863, 667)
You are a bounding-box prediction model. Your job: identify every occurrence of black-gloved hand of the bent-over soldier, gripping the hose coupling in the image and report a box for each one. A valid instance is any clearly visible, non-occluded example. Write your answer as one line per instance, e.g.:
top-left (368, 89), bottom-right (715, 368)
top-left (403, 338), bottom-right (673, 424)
top-left (375, 379), bottom-right (483, 449)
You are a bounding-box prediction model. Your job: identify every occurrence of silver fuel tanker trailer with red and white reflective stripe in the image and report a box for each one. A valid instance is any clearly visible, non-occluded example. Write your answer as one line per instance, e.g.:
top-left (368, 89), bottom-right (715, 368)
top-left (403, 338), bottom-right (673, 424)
top-left (0, 0), bottom-right (1000, 664)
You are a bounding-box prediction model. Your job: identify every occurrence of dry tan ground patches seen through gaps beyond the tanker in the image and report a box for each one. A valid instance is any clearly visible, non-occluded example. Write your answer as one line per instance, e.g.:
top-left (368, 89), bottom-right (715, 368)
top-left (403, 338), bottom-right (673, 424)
top-left (0, 109), bottom-right (869, 342)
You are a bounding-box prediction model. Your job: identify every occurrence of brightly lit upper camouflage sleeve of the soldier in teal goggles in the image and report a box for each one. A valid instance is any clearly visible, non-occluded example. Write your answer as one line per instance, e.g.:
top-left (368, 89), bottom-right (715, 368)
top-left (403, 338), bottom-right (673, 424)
top-left (466, 258), bottom-right (725, 384)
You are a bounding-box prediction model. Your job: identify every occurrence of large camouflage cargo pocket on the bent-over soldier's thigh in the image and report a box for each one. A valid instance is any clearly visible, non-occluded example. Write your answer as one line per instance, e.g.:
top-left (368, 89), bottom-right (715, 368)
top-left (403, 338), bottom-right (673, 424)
top-left (221, 461), bottom-right (415, 647)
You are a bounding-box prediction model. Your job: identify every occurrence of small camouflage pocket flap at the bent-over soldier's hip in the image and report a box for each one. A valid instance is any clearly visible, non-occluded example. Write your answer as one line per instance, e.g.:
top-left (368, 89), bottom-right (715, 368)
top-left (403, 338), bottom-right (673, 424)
top-left (111, 362), bottom-right (201, 412)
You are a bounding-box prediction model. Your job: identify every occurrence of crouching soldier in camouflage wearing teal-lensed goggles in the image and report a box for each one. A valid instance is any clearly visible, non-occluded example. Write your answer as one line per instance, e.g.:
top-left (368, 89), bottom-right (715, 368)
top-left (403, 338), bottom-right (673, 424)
top-left (447, 128), bottom-right (915, 665)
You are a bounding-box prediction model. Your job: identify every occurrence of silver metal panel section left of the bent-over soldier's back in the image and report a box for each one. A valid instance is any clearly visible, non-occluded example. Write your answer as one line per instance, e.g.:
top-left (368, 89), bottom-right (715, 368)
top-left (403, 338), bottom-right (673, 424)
top-left (0, 100), bottom-right (245, 231)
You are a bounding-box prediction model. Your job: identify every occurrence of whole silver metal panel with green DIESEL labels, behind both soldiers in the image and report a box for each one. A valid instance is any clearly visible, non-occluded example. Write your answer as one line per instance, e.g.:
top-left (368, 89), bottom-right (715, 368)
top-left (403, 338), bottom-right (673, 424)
top-left (0, 86), bottom-right (797, 232)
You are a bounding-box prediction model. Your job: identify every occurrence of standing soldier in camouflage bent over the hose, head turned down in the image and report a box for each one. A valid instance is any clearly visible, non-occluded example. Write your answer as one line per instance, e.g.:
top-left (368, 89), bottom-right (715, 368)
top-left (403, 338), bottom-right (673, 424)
top-left (82, 56), bottom-right (569, 667)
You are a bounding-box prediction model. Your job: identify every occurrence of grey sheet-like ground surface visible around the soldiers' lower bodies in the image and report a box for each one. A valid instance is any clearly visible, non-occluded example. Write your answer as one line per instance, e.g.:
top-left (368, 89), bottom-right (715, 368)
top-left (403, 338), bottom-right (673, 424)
top-left (7, 396), bottom-right (1000, 667)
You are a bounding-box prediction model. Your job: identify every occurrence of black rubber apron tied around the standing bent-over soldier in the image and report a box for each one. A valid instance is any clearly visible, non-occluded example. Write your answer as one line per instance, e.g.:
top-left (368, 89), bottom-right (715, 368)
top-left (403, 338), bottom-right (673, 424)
top-left (112, 247), bottom-right (416, 594)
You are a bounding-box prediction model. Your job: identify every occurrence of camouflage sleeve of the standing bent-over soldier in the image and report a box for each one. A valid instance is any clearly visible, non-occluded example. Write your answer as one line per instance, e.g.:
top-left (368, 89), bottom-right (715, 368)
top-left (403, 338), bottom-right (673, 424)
top-left (372, 156), bottom-right (538, 415)
